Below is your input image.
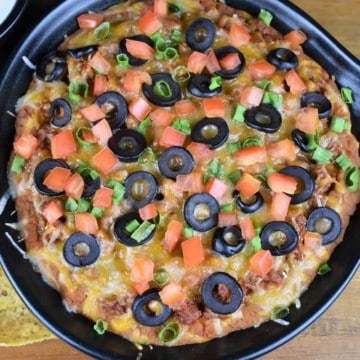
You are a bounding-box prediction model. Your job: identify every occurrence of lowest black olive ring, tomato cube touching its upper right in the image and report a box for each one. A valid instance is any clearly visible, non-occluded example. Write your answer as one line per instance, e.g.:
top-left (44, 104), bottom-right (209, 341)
top-left (131, 289), bottom-right (172, 326)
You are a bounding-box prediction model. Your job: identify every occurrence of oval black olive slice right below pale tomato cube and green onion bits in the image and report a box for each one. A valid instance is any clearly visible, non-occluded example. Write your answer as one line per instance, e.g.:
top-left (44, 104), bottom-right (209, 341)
top-left (245, 104), bottom-right (282, 133)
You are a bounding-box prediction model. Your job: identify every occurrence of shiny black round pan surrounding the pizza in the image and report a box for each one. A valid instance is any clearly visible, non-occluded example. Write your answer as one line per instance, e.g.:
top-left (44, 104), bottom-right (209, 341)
top-left (0, 0), bottom-right (360, 360)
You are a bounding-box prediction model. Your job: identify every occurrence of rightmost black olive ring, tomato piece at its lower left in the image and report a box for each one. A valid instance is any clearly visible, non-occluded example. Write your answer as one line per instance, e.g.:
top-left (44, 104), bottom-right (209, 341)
top-left (306, 206), bottom-right (343, 245)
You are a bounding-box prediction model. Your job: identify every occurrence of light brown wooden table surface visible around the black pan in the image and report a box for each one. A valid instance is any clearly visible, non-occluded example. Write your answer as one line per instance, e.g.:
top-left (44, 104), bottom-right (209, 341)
top-left (0, 0), bottom-right (360, 360)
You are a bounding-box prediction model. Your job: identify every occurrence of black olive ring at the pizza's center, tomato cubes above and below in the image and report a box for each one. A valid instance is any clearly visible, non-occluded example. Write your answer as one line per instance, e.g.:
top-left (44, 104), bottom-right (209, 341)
top-left (158, 146), bottom-right (194, 179)
